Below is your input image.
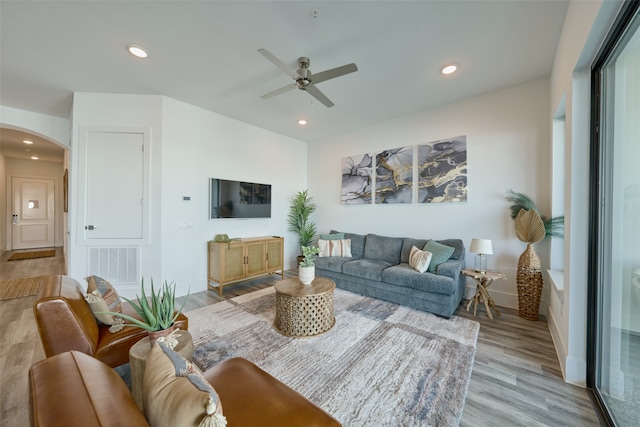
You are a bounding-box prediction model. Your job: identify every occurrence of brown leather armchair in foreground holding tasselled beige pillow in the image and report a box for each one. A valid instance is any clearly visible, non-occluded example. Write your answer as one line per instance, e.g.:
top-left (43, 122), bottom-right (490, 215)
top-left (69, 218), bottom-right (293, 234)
top-left (29, 351), bottom-right (341, 427)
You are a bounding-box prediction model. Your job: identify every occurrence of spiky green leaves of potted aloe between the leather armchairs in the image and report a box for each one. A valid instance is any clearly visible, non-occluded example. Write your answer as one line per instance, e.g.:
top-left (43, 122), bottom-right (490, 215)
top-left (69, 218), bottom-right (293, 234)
top-left (104, 278), bottom-right (189, 332)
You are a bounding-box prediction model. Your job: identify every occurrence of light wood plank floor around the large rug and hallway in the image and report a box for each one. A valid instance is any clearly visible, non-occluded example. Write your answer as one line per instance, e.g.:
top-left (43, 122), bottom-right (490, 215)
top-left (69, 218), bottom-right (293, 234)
top-left (0, 249), bottom-right (599, 427)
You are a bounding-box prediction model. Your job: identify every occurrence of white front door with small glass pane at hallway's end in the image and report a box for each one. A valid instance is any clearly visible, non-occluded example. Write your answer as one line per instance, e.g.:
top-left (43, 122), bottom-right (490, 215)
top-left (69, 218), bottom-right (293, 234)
top-left (11, 177), bottom-right (55, 249)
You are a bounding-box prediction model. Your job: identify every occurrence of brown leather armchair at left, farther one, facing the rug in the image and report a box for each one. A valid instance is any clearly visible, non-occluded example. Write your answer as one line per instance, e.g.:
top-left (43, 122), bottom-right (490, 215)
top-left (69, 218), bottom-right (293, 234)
top-left (33, 276), bottom-right (189, 367)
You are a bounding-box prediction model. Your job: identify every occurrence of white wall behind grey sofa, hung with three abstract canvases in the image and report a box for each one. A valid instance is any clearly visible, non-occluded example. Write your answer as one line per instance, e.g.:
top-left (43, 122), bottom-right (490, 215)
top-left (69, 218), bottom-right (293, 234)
top-left (308, 79), bottom-right (551, 309)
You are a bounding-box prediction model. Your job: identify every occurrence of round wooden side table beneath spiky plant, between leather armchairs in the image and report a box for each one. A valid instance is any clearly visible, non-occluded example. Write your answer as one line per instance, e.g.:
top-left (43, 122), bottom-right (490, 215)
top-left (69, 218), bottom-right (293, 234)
top-left (129, 329), bottom-right (193, 413)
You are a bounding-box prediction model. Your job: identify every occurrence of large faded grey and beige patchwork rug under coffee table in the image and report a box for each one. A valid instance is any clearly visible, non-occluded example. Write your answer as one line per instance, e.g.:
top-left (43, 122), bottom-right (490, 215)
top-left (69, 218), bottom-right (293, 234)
top-left (185, 288), bottom-right (480, 427)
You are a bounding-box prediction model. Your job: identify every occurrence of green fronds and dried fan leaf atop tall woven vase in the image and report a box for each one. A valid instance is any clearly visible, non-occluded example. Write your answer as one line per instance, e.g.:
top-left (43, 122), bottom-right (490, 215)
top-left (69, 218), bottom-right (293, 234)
top-left (507, 190), bottom-right (564, 243)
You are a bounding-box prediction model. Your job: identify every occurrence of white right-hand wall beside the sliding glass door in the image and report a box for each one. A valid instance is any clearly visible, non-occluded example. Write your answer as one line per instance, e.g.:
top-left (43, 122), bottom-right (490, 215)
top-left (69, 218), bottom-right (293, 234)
top-left (548, 1), bottom-right (620, 386)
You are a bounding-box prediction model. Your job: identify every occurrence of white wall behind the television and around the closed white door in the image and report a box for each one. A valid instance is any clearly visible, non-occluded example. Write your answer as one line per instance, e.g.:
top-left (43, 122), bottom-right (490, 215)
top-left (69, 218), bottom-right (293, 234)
top-left (69, 93), bottom-right (307, 297)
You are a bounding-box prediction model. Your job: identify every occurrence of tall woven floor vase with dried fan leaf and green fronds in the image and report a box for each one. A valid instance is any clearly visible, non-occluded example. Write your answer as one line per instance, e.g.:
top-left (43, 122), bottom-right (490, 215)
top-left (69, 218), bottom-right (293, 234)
top-left (507, 191), bottom-right (564, 320)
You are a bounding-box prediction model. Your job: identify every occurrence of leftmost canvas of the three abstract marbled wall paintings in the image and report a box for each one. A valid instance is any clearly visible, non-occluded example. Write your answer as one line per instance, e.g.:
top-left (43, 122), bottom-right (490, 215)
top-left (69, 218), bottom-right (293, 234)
top-left (342, 154), bottom-right (373, 205)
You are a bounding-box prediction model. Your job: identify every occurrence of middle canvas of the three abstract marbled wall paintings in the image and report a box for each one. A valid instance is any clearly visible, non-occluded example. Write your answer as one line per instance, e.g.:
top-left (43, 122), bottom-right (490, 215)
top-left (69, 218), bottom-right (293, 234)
top-left (375, 147), bottom-right (413, 203)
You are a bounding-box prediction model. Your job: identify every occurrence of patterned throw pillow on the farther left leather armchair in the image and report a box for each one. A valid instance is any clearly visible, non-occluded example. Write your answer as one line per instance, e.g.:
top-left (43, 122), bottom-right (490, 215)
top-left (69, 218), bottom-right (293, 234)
top-left (84, 276), bottom-right (124, 333)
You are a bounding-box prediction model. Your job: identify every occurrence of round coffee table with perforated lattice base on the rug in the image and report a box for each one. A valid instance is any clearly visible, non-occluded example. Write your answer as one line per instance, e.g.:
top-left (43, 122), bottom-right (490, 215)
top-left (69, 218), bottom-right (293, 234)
top-left (273, 277), bottom-right (336, 338)
